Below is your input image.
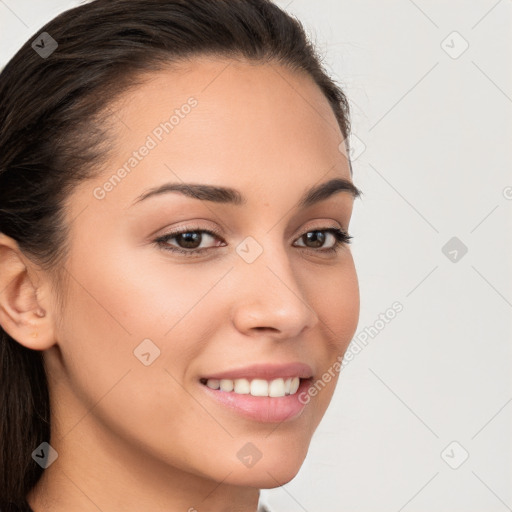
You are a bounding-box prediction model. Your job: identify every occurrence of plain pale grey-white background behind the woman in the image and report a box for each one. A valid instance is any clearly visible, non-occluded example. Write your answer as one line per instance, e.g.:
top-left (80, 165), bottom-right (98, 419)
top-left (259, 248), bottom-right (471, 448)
top-left (0, 0), bottom-right (512, 512)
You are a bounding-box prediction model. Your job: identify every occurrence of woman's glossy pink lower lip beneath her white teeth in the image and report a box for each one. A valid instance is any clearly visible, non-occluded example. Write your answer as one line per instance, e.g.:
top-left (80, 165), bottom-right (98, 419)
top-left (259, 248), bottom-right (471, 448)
top-left (199, 379), bottom-right (312, 423)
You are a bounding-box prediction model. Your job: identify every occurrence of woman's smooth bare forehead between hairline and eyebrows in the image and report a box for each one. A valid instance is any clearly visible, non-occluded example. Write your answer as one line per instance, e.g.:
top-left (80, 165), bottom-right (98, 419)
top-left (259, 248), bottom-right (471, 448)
top-left (74, 57), bottom-right (350, 214)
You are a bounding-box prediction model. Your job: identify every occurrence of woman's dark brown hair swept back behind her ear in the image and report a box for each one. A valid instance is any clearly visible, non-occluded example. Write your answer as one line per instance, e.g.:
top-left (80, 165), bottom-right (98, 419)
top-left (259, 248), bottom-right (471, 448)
top-left (0, 0), bottom-right (350, 506)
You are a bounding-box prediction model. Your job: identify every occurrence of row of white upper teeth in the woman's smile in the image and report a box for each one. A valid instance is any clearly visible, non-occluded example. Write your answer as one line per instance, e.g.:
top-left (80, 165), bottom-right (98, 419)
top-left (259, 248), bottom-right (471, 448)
top-left (206, 377), bottom-right (300, 397)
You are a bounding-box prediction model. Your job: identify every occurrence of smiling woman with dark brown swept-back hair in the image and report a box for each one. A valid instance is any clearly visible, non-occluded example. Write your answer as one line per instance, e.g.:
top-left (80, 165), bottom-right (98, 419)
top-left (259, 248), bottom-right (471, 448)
top-left (0, 0), bottom-right (360, 512)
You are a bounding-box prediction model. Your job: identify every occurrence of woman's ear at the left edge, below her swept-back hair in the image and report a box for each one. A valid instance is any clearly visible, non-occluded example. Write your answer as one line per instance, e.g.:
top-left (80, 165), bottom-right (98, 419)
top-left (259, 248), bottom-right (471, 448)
top-left (0, 233), bottom-right (55, 350)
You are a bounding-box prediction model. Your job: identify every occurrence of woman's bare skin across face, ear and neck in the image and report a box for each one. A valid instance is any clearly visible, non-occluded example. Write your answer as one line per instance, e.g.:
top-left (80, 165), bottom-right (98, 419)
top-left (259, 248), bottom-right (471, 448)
top-left (0, 58), bottom-right (359, 512)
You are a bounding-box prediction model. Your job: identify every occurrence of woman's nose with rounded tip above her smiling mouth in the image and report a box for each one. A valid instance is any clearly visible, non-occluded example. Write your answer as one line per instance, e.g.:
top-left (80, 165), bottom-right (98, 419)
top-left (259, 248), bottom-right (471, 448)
top-left (232, 237), bottom-right (318, 339)
